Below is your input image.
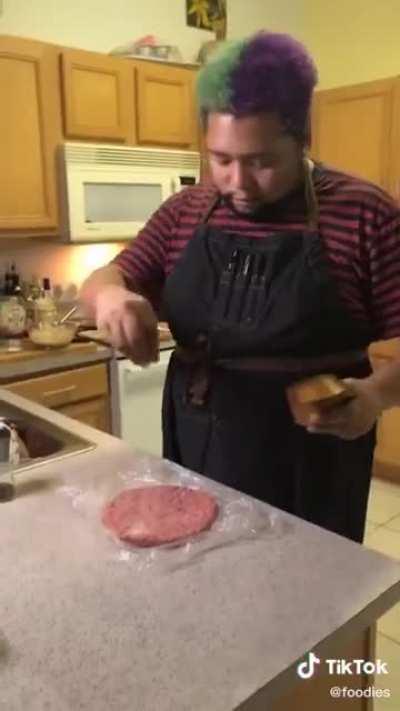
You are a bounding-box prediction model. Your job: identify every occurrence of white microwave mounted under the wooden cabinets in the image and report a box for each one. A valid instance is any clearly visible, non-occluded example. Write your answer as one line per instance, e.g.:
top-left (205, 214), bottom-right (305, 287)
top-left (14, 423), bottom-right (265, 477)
top-left (61, 143), bottom-right (200, 242)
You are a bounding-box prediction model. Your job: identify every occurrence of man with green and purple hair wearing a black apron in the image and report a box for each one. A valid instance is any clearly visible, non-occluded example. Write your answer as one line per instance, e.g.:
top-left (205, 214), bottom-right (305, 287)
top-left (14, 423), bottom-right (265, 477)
top-left (82, 32), bottom-right (400, 541)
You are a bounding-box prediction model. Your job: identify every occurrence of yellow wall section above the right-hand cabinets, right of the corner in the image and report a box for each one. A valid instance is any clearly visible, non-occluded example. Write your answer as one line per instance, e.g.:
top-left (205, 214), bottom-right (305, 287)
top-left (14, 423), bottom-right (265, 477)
top-left (303, 0), bottom-right (400, 89)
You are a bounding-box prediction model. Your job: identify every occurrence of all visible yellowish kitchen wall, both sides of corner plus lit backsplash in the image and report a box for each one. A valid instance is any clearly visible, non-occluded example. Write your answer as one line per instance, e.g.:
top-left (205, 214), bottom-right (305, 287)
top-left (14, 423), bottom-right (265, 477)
top-left (0, 0), bottom-right (400, 291)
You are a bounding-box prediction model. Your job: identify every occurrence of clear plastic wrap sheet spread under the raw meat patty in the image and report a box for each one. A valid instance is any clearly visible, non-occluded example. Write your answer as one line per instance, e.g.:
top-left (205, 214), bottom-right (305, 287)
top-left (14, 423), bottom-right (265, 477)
top-left (60, 454), bottom-right (283, 569)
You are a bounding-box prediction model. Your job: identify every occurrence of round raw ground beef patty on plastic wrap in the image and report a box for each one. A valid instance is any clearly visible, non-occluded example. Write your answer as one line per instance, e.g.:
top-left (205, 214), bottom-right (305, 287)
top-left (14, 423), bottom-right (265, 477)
top-left (102, 485), bottom-right (218, 547)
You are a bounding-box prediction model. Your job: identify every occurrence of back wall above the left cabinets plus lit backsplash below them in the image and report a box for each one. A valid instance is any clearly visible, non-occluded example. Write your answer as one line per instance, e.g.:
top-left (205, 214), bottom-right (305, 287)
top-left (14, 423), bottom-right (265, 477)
top-left (0, 0), bottom-right (304, 298)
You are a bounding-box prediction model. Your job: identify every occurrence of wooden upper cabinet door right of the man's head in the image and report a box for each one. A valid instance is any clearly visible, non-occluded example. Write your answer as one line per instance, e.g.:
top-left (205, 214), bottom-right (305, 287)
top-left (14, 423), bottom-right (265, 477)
top-left (312, 79), bottom-right (396, 191)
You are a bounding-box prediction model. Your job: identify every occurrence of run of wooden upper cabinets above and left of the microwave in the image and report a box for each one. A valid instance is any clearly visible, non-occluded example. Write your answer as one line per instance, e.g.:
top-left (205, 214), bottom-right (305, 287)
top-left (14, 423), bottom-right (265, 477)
top-left (0, 36), bottom-right (199, 237)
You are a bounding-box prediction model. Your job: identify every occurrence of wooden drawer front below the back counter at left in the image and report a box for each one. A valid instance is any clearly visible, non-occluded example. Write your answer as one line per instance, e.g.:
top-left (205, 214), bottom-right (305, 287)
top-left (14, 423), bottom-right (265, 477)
top-left (5, 364), bottom-right (108, 407)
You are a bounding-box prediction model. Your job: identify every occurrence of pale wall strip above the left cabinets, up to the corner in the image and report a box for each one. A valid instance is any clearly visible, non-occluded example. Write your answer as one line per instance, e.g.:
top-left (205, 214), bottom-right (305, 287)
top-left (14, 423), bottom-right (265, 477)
top-left (0, 0), bottom-right (303, 62)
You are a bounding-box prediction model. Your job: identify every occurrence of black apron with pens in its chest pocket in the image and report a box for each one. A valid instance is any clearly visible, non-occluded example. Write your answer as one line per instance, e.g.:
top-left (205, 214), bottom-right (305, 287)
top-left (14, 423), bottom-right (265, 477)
top-left (159, 192), bottom-right (375, 542)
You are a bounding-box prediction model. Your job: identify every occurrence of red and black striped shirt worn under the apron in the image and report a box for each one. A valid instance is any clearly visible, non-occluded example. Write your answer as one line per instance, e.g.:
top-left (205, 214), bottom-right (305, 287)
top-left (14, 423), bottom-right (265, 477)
top-left (114, 164), bottom-right (400, 340)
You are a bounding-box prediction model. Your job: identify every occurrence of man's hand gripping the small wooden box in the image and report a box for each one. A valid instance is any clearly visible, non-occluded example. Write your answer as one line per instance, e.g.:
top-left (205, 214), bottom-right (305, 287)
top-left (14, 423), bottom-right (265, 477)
top-left (307, 378), bottom-right (382, 440)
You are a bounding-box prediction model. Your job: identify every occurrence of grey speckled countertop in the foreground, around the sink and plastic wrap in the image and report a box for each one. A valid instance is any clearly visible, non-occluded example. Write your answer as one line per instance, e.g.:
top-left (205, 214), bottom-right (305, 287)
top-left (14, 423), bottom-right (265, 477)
top-left (0, 388), bottom-right (400, 711)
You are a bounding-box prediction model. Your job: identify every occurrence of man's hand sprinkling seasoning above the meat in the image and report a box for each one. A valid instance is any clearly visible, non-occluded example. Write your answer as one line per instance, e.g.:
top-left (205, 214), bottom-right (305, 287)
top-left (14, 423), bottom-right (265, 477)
top-left (96, 285), bottom-right (159, 366)
